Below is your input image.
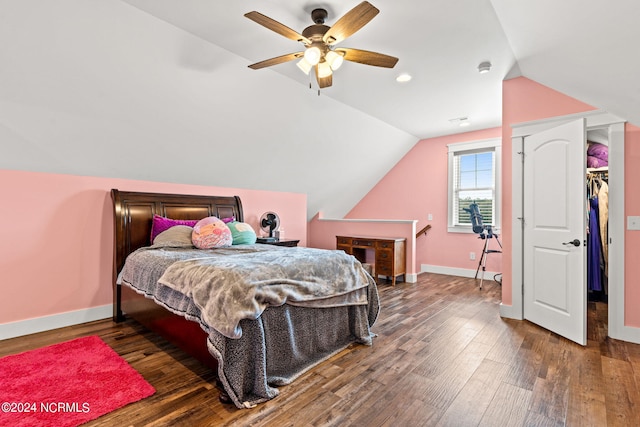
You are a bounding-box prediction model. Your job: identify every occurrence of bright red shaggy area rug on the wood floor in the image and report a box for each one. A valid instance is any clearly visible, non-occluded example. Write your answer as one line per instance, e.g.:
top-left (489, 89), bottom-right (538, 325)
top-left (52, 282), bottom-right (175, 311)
top-left (0, 336), bottom-right (155, 427)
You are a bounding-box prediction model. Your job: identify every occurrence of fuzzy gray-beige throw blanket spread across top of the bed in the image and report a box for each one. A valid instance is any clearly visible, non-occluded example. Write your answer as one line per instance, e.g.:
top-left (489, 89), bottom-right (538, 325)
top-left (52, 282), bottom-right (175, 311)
top-left (159, 245), bottom-right (370, 338)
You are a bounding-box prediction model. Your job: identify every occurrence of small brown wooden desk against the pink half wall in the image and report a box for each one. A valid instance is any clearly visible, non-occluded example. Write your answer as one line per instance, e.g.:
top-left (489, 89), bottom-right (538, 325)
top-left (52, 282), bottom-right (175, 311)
top-left (336, 236), bottom-right (407, 286)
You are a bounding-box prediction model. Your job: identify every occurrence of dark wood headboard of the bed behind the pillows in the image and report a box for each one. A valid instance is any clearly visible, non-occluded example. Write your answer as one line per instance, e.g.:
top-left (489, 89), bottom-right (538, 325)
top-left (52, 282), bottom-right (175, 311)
top-left (111, 189), bottom-right (244, 320)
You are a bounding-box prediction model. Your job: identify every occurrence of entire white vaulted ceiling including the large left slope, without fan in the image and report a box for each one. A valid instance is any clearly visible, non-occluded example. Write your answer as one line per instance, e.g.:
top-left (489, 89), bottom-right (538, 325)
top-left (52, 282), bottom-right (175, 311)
top-left (0, 0), bottom-right (640, 216)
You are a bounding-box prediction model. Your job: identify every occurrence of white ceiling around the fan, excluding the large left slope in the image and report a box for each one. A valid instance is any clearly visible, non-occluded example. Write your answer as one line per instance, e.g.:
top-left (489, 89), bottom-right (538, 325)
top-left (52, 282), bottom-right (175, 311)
top-left (126, 0), bottom-right (640, 138)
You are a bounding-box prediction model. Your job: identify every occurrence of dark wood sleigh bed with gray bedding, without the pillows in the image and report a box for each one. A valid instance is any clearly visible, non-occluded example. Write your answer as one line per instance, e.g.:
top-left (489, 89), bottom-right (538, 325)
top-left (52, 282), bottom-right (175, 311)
top-left (111, 189), bottom-right (379, 408)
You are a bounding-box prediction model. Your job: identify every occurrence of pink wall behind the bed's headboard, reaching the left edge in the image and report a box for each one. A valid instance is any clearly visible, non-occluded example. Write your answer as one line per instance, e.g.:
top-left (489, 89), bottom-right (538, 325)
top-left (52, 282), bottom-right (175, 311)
top-left (0, 170), bottom-right (307, 324)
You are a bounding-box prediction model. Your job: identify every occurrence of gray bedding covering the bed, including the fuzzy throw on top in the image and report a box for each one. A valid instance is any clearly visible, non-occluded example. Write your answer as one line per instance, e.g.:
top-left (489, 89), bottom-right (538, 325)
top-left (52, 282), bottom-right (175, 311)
top-left (120, 245), bottom-right (379, 408)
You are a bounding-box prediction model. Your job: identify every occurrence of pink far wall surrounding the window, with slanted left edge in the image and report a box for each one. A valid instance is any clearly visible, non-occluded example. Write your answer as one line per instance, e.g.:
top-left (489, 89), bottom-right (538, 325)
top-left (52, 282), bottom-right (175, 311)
top-left (346, 128), bottom-right (502, 272)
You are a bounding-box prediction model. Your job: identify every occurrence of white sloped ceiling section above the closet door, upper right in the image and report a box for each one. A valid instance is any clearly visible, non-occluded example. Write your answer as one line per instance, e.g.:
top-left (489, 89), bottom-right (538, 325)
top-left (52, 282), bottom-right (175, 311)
top-left (491, 0), bottom-right (640, 125)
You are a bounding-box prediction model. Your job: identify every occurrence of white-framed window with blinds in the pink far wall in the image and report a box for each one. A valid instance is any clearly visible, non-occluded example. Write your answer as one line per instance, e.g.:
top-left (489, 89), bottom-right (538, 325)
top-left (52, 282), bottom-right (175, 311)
top-left (448, 139), bottom-right (501, 233)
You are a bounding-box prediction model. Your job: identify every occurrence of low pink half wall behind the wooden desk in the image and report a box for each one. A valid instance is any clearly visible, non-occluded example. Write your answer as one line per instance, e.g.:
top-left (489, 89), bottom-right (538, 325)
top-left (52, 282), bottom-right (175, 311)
top-left (308, 213), bottom-right (420, 280)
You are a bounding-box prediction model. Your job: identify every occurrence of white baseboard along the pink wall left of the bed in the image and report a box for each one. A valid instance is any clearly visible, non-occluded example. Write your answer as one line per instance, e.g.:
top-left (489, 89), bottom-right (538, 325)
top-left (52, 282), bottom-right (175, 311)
top-left (0, 304), bottom-right (113, 340)
